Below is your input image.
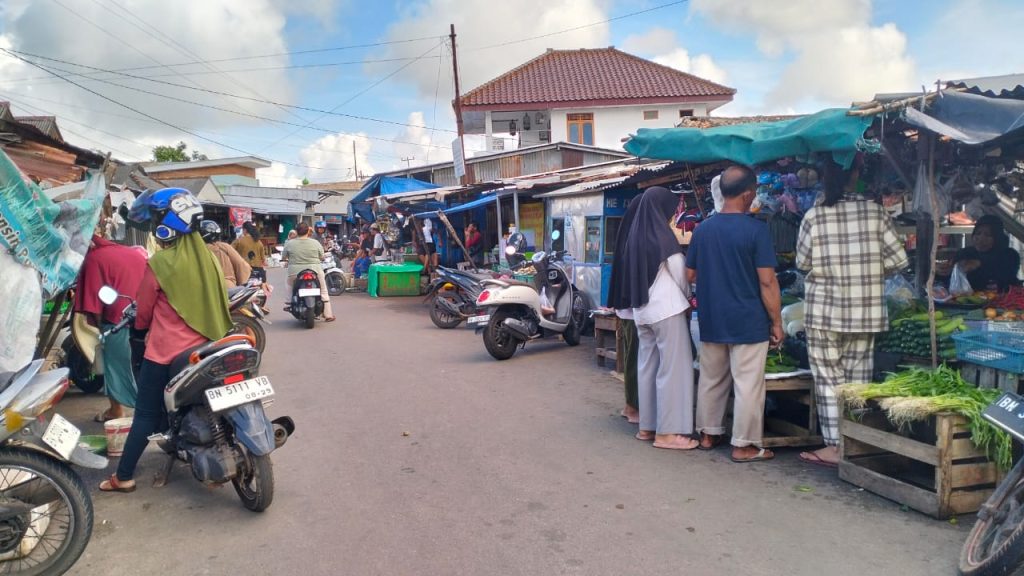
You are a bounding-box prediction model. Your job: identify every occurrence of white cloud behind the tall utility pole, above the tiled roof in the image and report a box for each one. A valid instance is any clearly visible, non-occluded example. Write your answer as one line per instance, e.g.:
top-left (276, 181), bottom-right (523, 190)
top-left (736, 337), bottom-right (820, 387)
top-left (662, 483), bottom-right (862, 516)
top-left (376, 0), bottom-right (609, 102)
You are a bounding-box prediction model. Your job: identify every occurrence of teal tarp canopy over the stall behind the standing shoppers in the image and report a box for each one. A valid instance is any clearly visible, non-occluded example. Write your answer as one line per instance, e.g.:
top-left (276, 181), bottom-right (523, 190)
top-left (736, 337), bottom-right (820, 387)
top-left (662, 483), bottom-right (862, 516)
top-left (626, 109), bottom-right (873, 167)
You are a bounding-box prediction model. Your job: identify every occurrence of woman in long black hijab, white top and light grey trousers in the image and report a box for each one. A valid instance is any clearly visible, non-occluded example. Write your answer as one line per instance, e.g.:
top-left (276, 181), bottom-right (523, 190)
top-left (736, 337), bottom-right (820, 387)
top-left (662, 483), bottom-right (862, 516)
top-left (623, 187), bottom-right (699, 450)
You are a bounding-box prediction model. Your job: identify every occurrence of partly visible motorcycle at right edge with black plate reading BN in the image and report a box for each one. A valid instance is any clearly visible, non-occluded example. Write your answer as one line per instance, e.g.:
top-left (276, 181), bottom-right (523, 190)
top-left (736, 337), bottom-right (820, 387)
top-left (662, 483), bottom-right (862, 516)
top-left (959, 393), bottom-right (1024, 576)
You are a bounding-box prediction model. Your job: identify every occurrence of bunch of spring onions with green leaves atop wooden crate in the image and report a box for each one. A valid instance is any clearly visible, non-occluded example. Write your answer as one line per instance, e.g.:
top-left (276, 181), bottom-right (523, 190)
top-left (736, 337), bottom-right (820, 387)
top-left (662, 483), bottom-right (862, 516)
top-left (840, 365), bottom-right (1013, 469)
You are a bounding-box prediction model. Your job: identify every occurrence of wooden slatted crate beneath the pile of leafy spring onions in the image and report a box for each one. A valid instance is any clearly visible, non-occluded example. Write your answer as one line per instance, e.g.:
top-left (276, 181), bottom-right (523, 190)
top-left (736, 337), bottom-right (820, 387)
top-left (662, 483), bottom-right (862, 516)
top-left (839, 404), bottom-right (1002, 519)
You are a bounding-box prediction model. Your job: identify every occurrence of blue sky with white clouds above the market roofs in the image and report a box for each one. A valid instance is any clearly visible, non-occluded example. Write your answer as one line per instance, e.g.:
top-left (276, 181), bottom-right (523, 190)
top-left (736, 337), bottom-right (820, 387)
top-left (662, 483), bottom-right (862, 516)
top-left (0, 0), bottom-right (1024, 187)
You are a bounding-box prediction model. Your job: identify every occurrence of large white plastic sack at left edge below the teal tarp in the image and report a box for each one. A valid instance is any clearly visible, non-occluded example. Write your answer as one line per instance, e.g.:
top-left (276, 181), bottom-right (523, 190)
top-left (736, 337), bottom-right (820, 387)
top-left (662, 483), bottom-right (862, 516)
top-left (0, 250), bottom-right (41, 372)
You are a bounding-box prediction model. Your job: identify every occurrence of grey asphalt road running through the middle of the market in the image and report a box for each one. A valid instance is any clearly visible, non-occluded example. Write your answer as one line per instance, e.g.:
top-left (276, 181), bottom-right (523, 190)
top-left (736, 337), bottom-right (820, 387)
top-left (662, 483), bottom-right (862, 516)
top-left (60, 271), bottom-right (972, 576)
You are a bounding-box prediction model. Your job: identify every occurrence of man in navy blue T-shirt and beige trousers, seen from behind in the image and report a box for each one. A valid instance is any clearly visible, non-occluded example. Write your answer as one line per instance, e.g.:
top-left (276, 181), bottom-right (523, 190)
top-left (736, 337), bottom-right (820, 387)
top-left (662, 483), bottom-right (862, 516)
top-left (686, 166), bottom-right (783, 462)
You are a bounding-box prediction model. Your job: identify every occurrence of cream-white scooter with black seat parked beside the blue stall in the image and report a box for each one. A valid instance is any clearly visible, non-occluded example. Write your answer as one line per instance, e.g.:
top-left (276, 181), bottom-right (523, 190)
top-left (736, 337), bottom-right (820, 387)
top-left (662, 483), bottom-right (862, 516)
top-left (466, 231), bottom-right (590, 360)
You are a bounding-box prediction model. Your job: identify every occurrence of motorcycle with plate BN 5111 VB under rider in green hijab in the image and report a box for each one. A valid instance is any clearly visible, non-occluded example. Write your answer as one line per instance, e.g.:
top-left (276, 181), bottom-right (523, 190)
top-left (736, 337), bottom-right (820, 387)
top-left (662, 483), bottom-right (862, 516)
top-left (99, 286), bottom-right (295, 512)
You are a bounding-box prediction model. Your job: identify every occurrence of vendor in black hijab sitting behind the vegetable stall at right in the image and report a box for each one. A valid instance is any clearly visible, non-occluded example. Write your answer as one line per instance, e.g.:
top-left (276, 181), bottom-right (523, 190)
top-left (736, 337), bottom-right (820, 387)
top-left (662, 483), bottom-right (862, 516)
top-left (955, 214), bottom-right (1021, 292)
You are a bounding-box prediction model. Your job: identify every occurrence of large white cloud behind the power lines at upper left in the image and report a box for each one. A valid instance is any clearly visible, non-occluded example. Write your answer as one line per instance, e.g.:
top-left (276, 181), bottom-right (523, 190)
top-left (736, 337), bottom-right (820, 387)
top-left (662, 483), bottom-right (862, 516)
top-left (0, 0), bottom-right (342, 155)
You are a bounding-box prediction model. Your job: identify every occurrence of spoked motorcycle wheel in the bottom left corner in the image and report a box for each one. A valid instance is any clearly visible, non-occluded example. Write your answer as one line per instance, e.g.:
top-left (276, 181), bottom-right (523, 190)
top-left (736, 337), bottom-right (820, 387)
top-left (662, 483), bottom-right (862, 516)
top-left (0, 448), bottom-right (92, 576)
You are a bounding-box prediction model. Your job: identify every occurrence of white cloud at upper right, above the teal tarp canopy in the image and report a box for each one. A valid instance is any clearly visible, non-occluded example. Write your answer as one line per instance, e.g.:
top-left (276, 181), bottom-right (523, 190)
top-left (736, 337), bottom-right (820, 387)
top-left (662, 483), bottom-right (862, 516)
top-left (690, 0), bottom-right (916, 111)
